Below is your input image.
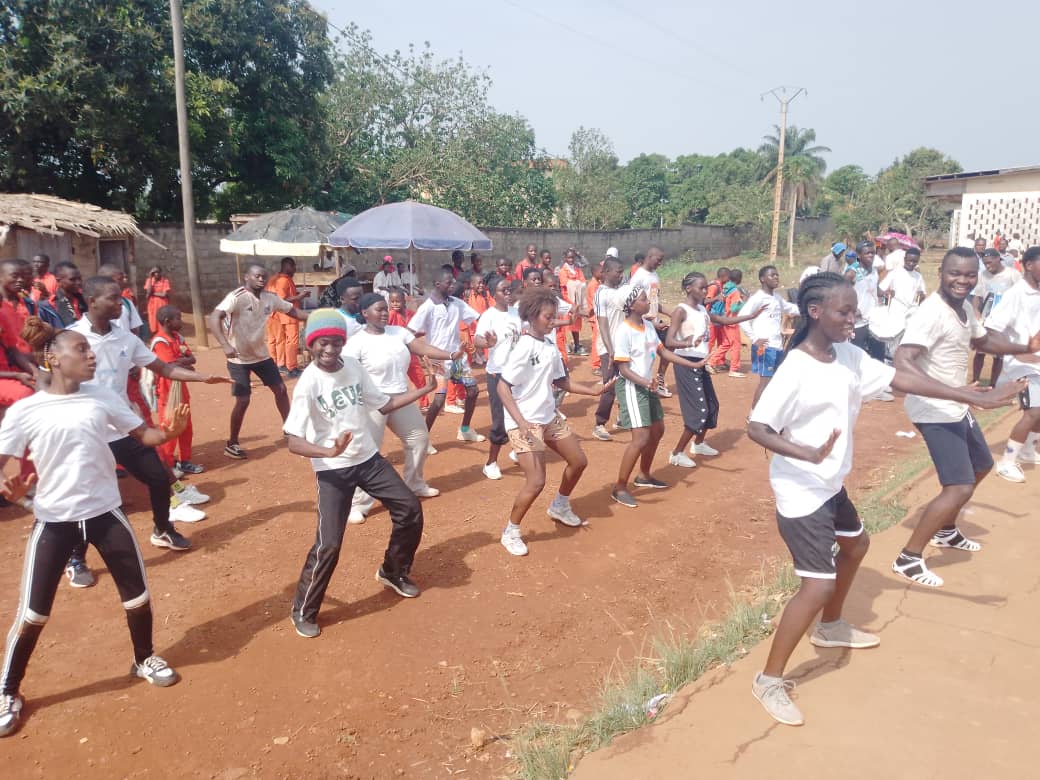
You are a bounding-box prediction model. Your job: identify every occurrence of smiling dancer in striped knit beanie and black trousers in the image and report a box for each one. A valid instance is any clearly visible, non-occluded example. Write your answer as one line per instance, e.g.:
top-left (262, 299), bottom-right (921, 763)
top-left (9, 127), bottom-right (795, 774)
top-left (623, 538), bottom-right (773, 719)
top-left (284, 309), bottom-right (434, 639)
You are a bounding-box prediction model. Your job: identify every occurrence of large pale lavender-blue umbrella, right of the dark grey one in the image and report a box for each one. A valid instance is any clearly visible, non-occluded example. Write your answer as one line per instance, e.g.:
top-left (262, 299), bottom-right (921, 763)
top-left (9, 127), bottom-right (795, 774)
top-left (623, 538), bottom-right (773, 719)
top-left (329, 201), bottom-right (491, 293)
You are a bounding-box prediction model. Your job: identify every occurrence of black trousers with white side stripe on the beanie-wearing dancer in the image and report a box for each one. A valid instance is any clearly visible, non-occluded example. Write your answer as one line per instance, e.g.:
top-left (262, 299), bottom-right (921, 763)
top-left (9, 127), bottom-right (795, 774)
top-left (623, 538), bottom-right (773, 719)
top-left (292, 453), bottom-right (422, 621)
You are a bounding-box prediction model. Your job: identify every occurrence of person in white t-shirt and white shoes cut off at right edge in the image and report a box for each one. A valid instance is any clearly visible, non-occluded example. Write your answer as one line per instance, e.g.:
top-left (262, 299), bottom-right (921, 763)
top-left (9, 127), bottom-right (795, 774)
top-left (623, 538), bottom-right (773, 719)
top-left (986, 246), bottom-right (1040, 483)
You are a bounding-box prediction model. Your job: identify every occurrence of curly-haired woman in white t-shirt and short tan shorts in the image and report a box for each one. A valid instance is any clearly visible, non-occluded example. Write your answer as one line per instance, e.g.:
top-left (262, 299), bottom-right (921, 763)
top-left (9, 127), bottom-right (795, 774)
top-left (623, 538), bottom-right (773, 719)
top-left (497, 287), bottom-right (612, 555)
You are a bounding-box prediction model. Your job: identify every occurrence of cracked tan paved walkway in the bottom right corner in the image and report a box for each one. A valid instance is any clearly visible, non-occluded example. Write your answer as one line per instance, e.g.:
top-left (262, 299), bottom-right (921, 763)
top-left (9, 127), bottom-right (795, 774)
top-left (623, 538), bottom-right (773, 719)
top-left (573, 419), bottom-right (1040, 780)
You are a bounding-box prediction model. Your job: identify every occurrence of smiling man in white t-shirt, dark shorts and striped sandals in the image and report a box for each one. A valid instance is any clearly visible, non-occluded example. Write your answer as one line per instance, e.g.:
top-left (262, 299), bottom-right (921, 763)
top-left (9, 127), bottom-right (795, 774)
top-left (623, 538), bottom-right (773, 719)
top-left (892, 248), bottom-right (1040, 588)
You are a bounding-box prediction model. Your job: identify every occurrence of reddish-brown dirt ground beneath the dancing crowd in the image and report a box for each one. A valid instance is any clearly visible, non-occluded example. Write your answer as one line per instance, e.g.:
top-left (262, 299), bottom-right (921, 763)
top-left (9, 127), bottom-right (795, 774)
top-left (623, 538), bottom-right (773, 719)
top-left (0, 332), bottom-right (921, 780)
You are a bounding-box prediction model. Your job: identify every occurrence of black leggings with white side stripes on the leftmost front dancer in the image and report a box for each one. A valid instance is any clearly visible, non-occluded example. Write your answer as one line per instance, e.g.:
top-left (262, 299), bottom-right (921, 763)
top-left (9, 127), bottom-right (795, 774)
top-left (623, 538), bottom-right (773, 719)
top-left (0, 510), bottom-right (152, 696)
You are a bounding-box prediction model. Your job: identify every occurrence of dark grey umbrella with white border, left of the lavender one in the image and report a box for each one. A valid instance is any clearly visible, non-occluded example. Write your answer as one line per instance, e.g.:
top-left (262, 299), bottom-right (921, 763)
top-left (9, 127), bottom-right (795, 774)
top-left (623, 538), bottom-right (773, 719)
top-left (220, 206), bottom-right (349, 257)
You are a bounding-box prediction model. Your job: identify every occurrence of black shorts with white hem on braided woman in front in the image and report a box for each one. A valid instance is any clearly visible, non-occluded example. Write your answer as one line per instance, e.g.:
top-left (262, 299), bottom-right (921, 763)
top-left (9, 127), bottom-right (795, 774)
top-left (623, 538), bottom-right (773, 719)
top-left (777, 488), bottom-right (863, 579)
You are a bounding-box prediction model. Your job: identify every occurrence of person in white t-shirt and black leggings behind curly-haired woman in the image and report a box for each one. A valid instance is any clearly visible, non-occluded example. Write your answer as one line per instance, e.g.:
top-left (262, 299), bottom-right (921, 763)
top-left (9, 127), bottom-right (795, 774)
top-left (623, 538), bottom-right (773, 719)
top-left (473, 276), bottom-right (523, 479)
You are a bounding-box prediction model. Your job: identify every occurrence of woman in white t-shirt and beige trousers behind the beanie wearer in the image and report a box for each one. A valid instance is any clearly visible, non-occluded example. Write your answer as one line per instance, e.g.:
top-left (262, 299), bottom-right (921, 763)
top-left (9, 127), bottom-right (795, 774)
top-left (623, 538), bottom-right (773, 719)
top-left (343, 292), bottom-right (451, 523)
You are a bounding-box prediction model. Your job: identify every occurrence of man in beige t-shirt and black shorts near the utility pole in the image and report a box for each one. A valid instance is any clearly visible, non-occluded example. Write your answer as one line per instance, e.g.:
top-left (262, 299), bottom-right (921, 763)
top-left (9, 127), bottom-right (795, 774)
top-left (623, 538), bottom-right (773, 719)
top-left (206, 263), bottom-right (307, 461)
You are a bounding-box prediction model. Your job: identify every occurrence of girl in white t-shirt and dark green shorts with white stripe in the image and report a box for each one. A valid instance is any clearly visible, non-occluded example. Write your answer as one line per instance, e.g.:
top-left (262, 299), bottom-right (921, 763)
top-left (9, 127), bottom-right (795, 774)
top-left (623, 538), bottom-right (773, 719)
top-left (610, 286), bottom-right (705, 508)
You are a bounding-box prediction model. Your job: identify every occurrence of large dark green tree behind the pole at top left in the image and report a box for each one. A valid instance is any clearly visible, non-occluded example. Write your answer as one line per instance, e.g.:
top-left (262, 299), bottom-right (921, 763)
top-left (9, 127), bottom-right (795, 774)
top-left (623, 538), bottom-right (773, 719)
top-left (0, 0), bottom-right (332, 218)
